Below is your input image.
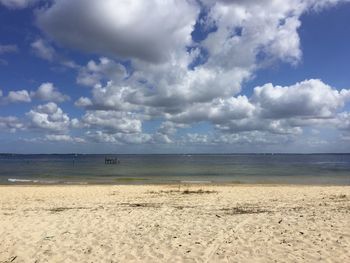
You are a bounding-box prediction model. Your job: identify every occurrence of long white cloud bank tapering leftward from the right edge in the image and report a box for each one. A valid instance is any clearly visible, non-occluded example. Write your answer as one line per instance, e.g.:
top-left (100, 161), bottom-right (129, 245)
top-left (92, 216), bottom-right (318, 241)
top-left (166, 79), bottom-right (350, 135)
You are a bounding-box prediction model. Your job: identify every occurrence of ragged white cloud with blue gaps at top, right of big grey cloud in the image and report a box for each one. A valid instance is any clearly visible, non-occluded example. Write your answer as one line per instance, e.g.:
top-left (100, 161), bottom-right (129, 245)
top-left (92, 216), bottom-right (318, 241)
top-left (203, 1), bottom-right (305, 68)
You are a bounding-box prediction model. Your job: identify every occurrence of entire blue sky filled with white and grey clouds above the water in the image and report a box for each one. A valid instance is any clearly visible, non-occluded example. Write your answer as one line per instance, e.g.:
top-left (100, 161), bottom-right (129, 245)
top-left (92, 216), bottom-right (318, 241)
top-left (0, 0), bottom-right (350, 153)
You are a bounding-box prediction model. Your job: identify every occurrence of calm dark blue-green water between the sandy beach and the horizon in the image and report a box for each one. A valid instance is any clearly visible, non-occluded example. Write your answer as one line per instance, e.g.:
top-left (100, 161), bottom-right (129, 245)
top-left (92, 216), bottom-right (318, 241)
top-left (0, 154), bottom-right (350, 185)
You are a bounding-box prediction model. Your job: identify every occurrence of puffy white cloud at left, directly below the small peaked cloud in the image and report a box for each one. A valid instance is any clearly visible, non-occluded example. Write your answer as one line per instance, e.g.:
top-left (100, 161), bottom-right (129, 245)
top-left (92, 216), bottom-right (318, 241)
top-left (26, 102), bottom-right (70, 133)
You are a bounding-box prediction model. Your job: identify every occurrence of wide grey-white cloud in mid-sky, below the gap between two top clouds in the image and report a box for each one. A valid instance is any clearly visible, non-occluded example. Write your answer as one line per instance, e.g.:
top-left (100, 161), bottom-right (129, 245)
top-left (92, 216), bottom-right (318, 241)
top-left (129, 67), bottom-right (249, 112)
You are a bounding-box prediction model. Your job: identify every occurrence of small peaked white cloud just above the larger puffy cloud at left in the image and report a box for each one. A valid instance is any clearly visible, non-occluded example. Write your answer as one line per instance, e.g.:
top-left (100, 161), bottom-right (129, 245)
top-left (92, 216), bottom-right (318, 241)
top-left (30, 82), bottom-right (69, 102)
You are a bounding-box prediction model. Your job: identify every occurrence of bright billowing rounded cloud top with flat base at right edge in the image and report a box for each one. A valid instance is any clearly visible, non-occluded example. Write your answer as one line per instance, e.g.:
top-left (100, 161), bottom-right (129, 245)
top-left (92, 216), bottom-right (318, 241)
top-left (253, 79), bottom-right (350, 118)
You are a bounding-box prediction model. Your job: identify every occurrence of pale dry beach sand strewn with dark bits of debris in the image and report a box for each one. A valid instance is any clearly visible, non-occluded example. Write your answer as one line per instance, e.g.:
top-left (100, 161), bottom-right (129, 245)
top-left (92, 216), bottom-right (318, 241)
top-left (0, 185), bottom-right (350, 262)
